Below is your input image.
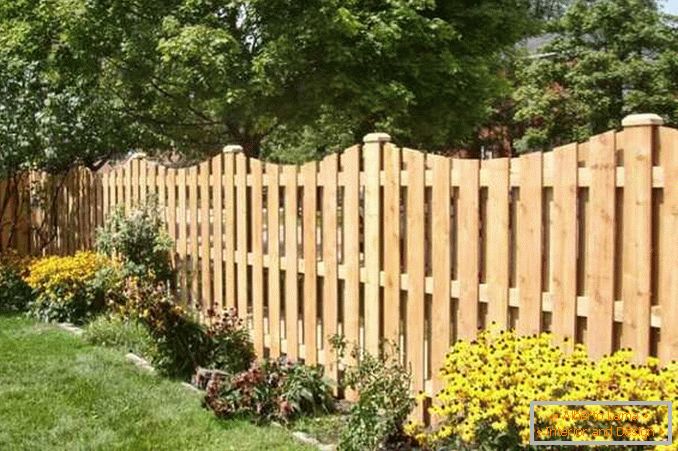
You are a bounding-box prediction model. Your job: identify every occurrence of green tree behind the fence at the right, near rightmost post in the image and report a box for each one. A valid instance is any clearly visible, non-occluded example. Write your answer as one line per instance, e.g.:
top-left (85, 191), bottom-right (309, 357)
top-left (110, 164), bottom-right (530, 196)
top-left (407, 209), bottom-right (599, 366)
top-left (514, 0), bottom-right (678, 150)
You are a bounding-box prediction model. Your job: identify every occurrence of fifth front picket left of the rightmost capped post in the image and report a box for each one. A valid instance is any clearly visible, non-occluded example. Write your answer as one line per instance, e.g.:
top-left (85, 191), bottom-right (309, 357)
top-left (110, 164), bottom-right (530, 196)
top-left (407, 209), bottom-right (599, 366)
top-left (455, 160), bottom-right (480, 340)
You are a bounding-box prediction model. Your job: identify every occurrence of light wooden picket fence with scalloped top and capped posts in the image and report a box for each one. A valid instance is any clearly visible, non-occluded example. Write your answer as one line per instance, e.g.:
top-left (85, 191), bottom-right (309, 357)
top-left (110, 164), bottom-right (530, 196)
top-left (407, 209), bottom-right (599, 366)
top-left (1, 115), bottom-right (678, 416)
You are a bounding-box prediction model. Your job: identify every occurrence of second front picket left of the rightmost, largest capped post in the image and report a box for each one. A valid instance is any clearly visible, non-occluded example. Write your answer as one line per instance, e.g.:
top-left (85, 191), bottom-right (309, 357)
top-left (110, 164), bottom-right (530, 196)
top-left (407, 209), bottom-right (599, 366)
top-left (551, 144), bottom-right (577, 348)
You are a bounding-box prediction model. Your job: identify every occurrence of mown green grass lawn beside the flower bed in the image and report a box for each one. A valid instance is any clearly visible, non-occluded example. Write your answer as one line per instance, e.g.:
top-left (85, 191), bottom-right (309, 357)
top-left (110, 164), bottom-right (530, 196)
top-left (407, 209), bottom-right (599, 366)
top-left (0, 315), bottom-right (313, 451)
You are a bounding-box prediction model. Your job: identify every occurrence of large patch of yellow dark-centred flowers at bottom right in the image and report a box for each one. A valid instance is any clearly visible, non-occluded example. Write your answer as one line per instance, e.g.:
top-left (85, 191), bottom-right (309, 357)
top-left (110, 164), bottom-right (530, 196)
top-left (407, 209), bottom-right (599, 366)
top-left (406, 330), bottom-right (678, 449)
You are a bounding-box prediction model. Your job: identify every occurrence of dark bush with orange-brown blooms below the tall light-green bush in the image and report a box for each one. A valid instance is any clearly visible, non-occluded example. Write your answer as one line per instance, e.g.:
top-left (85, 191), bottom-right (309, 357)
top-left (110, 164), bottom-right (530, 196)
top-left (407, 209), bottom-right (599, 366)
top-left (117, 277), bottom-right (210, 379)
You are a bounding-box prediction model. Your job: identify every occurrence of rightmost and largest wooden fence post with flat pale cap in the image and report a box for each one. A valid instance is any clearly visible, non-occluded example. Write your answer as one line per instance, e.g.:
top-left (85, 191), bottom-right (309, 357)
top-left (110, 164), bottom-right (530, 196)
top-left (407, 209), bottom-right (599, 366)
top-left (620, 114), bottom-right (663, 362)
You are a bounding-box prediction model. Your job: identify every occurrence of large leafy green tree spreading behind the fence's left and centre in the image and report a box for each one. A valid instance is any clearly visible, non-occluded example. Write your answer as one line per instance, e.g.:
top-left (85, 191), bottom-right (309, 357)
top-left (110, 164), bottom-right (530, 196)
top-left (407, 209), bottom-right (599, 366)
top-left (0, 0), bottom-right (534, 159)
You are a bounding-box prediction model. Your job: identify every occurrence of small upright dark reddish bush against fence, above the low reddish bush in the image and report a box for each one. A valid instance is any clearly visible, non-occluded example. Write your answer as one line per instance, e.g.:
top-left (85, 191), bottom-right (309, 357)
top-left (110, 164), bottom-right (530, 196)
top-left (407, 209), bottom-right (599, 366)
top-left (205, 309), bottom-right (256, 374)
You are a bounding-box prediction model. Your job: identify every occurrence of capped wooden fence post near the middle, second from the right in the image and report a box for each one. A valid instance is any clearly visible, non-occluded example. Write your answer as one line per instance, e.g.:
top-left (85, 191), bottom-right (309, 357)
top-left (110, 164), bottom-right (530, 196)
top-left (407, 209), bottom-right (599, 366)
top-left (363, 133), bottom-right (391, 355)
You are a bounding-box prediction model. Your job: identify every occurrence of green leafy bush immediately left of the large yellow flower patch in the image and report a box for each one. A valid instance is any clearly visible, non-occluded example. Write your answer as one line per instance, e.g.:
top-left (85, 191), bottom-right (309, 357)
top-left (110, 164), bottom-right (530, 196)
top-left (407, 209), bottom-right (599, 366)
top-left (339, 344), bottom-right (414, 451)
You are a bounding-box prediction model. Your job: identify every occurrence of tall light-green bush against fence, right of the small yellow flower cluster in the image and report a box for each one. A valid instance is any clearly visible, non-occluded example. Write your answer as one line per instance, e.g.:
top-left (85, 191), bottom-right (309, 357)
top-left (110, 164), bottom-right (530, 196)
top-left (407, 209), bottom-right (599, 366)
top-left (96, 196), bottom-right (173, 281)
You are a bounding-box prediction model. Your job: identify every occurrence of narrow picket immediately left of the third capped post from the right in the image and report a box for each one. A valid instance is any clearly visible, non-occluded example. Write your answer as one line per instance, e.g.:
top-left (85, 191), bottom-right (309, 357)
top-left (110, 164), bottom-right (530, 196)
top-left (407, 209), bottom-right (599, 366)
top-left (210, 154), bottom-right (224, 314)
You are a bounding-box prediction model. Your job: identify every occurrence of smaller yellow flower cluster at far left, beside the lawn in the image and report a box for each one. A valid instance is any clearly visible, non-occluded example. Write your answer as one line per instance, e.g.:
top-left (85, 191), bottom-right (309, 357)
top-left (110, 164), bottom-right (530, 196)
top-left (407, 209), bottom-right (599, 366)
top-left (25, 252), bottom-right (111, 302)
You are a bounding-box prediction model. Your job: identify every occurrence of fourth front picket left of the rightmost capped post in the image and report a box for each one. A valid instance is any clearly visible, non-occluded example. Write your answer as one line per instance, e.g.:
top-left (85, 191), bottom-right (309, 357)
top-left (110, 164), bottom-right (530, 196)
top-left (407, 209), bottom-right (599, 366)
top-left (481, 158), bottom-right (509, 329)
